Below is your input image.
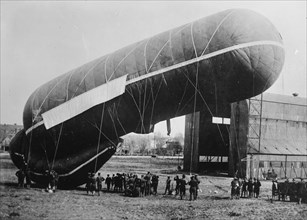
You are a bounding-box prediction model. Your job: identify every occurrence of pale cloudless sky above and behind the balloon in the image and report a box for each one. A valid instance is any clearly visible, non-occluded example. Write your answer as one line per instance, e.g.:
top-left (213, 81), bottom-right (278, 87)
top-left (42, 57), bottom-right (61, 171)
top-left (0, 1), bottom-right (307, 134)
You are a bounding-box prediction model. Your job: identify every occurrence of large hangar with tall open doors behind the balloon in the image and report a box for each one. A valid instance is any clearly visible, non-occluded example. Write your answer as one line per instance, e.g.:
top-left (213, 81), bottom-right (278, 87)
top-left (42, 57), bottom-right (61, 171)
top-left (184, 93), bottom-right (307, 179)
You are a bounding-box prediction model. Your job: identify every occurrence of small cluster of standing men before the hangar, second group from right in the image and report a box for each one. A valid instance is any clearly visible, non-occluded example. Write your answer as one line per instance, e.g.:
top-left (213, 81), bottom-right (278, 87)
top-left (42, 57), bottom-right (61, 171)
top-left (231, 177), bottom-right (261, 199)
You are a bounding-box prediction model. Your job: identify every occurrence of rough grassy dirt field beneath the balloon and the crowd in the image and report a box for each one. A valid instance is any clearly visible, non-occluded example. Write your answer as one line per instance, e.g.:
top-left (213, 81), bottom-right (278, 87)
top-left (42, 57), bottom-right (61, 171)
top-left (0, 157), bottom-right (307, 220)
